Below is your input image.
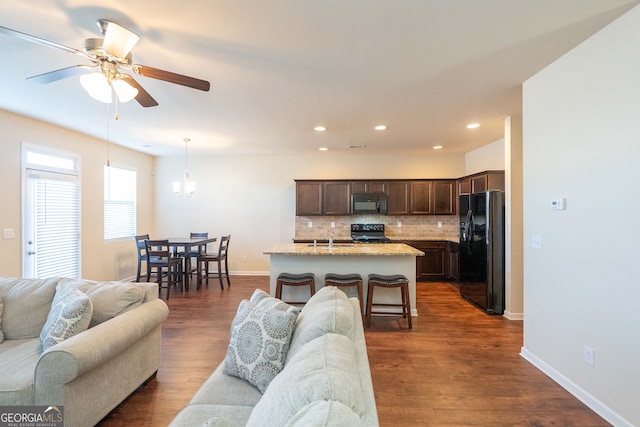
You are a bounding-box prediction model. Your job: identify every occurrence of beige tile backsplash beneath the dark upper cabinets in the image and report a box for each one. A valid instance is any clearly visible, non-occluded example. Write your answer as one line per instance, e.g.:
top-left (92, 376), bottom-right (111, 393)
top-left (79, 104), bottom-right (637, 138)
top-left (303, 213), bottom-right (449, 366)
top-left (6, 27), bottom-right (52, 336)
top-left (295, 215), bottom-right (460, 240)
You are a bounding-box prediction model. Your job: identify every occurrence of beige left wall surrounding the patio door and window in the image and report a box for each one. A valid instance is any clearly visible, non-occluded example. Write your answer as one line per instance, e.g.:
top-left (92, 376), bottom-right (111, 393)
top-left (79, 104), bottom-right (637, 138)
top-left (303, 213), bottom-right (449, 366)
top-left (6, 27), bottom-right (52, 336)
top-left (0, 110), bottom-right (154, 280)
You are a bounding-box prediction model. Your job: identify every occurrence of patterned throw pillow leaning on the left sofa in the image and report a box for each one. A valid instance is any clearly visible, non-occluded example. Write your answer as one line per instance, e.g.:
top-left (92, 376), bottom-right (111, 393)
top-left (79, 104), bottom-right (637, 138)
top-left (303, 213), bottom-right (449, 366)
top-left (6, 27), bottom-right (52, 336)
top-left (40, 289), bottom-right (93, 351)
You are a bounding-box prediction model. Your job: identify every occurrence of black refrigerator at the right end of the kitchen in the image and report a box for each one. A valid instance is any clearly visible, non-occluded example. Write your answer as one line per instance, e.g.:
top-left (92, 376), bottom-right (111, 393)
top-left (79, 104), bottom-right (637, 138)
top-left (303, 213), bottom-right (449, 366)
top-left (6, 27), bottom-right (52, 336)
top-left (459, 191), bottom-right (505, 314)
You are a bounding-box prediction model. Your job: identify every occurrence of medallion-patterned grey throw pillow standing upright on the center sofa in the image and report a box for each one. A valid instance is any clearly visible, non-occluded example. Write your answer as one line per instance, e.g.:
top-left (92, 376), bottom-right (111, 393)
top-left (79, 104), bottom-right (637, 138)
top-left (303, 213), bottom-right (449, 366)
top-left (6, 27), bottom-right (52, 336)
top-left (223, 300), bottom-right (298, 393)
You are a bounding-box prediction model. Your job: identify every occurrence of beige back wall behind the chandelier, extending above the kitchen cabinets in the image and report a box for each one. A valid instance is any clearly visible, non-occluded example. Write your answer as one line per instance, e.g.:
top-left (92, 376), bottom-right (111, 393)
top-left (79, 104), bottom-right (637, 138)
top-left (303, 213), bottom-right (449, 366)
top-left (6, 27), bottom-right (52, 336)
top-left (156, 152), bottom-right (464, 273)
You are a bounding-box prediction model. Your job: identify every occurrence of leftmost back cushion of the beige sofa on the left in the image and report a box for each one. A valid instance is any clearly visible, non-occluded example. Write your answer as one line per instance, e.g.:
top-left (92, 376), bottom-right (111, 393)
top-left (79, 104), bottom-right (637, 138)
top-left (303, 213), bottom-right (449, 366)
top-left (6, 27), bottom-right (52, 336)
top-left (0, 278), bottom-right (59, 340)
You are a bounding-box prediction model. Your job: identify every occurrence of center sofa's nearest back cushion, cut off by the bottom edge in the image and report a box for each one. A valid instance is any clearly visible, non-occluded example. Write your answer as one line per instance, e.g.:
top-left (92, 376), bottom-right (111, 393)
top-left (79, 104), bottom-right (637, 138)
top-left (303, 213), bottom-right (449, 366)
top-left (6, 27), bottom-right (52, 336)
top-left (287, 400), bottom-right (364, 427)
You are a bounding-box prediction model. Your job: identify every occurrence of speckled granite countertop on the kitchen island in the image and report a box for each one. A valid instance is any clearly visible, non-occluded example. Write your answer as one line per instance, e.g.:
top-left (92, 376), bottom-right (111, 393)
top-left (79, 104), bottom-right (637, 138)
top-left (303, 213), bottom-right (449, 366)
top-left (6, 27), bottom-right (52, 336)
top-left (263, 243), bottom-right (424, 256)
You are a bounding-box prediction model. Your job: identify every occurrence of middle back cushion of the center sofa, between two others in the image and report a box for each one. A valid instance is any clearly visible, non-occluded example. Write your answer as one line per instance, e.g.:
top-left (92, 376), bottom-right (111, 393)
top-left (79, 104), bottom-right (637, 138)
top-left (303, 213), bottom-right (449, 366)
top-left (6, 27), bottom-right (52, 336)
top-left (247, 333), bottom-right (364, 426)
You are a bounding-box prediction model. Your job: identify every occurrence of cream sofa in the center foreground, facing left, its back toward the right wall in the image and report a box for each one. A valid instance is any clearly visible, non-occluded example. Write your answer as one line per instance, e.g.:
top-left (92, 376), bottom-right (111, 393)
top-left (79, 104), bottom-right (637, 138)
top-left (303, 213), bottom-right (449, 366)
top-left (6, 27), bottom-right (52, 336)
top-left (170, 287), bottom-right (378, 427)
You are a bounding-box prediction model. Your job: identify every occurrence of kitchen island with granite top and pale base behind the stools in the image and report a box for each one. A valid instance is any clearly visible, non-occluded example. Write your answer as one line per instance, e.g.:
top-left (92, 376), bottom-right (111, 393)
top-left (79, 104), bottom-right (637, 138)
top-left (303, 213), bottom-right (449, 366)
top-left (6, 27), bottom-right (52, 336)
top-left (264, 243), bottom-right (424, 316)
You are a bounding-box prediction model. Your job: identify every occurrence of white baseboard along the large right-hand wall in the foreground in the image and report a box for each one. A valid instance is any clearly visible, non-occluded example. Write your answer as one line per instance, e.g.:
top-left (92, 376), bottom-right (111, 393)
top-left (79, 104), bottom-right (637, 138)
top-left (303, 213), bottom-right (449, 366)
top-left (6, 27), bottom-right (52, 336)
top-left (520, 347), bottom-right (633, 427)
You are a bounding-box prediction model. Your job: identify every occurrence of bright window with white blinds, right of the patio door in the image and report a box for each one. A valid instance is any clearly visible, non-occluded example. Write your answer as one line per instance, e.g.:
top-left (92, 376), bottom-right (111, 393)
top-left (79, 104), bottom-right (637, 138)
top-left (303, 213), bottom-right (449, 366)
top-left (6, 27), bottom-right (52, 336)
top-left (104, 166), bottom-right (136, 240)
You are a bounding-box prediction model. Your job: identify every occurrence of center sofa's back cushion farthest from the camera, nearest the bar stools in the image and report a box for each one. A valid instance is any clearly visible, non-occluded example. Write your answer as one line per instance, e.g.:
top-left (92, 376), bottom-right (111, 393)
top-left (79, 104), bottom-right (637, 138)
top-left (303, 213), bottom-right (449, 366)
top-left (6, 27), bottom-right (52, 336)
top-left (287, 286), bottom-right (362, 363)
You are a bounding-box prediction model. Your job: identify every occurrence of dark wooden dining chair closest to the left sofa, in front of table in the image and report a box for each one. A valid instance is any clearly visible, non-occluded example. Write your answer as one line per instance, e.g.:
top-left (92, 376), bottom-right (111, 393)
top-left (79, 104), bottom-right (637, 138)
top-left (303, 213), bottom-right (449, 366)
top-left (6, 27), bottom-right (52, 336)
top-left (144, 239), bottom-right (184, 300)
